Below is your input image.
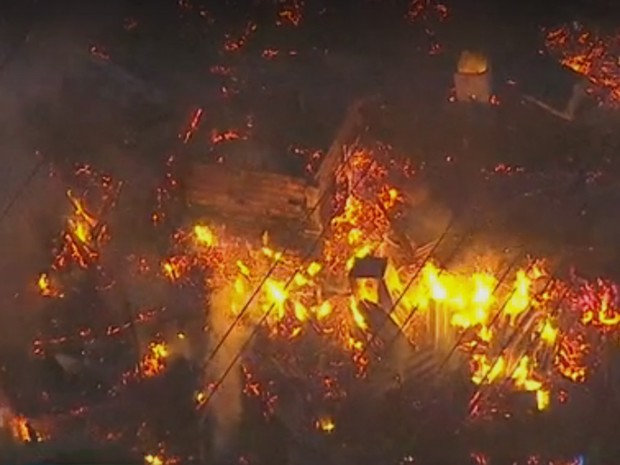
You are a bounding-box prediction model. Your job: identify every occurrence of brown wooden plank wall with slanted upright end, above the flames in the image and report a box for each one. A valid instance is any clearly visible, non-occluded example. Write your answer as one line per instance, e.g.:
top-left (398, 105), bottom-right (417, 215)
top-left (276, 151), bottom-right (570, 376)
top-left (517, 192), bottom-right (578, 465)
top-left (186, 98), bottom-right (376, 235)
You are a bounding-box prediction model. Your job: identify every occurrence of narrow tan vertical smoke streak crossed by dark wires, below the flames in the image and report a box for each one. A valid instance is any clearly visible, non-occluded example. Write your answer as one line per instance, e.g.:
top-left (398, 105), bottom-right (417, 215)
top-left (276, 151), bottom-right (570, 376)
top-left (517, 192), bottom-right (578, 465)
top-left (205, 285), bottom-right (250, 457)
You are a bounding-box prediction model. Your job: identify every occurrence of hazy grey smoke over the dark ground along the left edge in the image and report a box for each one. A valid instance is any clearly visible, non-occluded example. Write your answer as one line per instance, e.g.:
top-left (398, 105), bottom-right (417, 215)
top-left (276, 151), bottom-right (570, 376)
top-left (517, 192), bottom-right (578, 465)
top-left (0, 2), bottom-right (172, 350)
